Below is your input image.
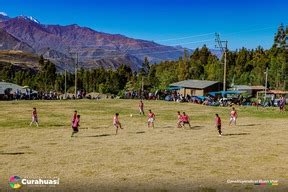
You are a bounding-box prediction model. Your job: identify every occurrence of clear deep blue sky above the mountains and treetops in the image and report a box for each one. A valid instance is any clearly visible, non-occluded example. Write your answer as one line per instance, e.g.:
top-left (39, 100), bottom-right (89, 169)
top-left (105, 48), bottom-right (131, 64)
top-left (0, 0), bottom-right (288, 49)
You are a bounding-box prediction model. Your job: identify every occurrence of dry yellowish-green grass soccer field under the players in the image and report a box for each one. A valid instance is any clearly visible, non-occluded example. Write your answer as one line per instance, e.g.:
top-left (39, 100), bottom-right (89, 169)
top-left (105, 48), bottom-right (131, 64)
top-left (0, 100), bottom-right (288, 191)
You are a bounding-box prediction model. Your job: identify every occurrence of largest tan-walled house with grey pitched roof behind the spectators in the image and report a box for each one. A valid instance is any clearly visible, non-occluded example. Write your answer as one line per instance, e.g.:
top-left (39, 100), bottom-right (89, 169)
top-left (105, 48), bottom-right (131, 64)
top-left (169, 79), bottom-right (223, 96)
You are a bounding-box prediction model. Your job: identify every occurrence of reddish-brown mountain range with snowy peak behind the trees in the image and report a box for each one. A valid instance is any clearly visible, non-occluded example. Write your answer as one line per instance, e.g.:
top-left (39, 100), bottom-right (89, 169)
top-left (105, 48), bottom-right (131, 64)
top-left (0, 14), bottom-right (184, 71)
